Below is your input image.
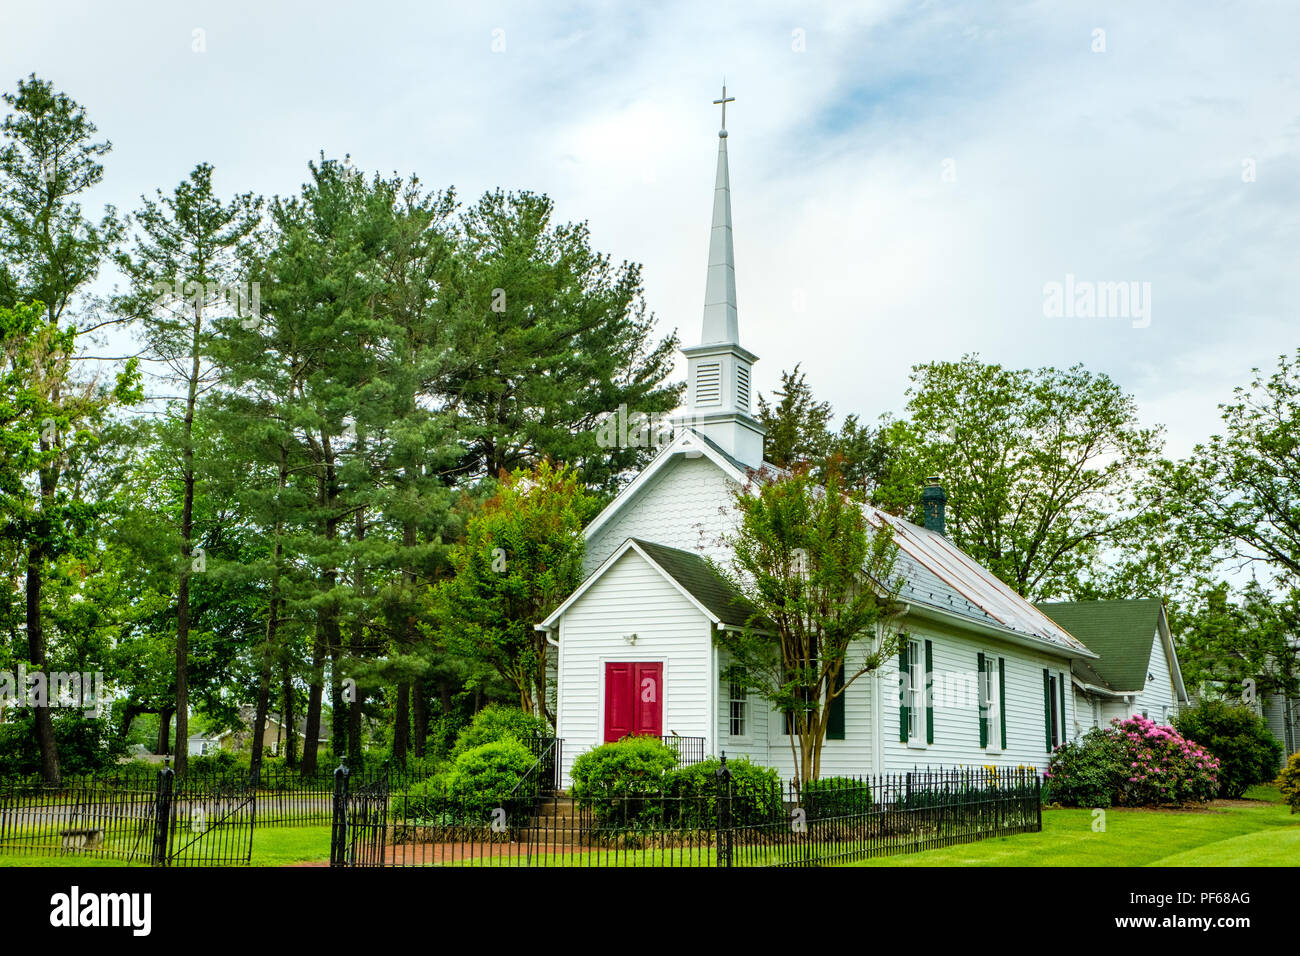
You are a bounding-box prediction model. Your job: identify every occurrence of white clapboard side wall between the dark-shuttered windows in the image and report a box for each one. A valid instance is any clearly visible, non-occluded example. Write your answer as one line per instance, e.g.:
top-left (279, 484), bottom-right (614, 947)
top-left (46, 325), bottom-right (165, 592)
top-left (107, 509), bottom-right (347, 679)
top-left (880, 624), bottom-right (1075, 773)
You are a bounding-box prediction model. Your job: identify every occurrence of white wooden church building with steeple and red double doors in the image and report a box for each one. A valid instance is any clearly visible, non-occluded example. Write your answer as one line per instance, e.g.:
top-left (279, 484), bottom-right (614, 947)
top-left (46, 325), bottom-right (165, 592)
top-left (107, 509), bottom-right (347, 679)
top-left (538, 90), bottom-right (1149, 787)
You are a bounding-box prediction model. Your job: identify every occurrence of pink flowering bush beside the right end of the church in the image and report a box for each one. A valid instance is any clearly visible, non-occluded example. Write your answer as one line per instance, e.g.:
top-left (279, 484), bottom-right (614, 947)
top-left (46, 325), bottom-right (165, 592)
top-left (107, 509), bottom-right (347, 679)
top-left (1047, 715), bottom-right (1219, 806)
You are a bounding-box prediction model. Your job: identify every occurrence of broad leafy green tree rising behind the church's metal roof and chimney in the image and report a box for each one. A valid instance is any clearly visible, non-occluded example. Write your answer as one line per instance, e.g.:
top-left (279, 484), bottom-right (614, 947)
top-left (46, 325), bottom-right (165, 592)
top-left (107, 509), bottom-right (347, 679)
top-left (876, 355), bottom-right (1160, 600)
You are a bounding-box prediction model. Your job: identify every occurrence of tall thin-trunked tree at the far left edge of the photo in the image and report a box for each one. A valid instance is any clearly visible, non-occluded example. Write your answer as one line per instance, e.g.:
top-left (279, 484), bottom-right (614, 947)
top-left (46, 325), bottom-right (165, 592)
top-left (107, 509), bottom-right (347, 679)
top-left (0, 74), bottom-right (129, 782)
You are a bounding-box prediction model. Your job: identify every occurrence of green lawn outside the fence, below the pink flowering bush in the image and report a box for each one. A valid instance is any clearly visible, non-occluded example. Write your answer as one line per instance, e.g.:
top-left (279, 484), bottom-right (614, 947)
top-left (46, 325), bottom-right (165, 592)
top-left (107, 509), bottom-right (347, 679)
top-left (855, 787), bottom-right (1300, 866)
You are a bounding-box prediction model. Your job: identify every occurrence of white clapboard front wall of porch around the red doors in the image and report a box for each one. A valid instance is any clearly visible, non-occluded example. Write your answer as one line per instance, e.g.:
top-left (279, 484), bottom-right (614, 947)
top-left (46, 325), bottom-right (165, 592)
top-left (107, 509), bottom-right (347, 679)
top-left (558, 550), bottom-right (712, 787)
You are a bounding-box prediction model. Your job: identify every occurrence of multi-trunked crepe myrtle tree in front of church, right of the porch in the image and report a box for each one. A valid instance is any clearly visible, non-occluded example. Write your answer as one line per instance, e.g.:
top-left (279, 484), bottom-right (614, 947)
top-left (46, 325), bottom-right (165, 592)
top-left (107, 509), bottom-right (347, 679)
top-left (714, 463), bottom-right (901, 787)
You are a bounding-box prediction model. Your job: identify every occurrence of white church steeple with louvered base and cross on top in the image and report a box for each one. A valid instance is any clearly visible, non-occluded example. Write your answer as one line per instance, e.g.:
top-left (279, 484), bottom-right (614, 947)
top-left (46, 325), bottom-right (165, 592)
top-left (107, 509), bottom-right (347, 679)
top-left (681, 86), bottom-right (763, 468)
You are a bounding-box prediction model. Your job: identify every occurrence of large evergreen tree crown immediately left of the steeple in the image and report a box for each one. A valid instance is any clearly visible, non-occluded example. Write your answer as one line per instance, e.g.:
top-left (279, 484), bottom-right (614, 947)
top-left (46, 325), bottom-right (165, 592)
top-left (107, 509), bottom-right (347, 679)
top-left (447, 191), bottom-right (684, 490)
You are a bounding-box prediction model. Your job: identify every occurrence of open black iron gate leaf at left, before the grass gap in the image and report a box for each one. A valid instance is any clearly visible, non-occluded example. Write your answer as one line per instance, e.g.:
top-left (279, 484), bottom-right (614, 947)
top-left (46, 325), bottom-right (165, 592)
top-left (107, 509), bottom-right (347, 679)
top-left (153, 774), bottom-right (257, 866)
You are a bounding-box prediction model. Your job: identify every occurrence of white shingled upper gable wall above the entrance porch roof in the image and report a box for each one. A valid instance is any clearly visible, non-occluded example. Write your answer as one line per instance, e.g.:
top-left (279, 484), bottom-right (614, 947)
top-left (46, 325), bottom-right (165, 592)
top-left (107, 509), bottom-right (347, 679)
top-left (584, 457), bottom-right (736, 574)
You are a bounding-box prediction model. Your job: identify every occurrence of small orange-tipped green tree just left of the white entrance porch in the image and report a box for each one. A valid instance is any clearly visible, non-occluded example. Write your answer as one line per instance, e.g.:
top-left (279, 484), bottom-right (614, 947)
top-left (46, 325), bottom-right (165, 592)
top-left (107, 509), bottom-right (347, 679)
top-left (434, 462), bottom-right (597, 726)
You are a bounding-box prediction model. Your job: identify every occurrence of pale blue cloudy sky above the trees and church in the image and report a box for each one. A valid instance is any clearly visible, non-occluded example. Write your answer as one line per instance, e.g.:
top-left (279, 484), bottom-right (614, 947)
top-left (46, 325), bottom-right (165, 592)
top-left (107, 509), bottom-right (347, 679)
top-left (0, 0), bottom-right (1300, 454)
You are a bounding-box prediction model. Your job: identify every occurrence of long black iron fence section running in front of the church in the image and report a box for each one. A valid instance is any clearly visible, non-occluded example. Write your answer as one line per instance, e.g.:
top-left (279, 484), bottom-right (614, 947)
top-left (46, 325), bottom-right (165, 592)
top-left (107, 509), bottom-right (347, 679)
top-left (330, 760), bottom-right (1041, 866)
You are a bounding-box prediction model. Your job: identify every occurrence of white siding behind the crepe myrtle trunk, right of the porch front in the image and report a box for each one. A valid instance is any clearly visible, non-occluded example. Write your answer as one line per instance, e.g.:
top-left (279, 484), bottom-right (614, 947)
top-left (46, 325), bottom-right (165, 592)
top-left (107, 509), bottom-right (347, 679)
top-left (718, 644), bottom-right (874, 782)
